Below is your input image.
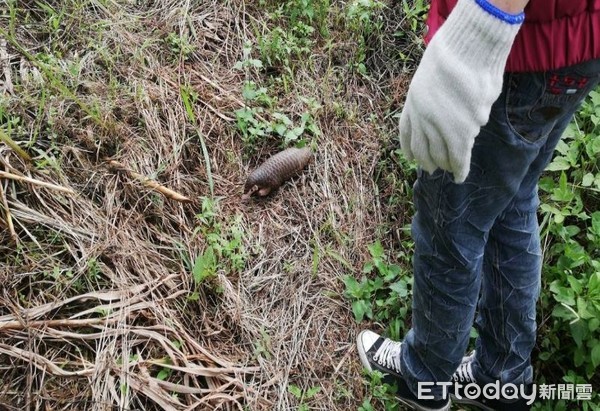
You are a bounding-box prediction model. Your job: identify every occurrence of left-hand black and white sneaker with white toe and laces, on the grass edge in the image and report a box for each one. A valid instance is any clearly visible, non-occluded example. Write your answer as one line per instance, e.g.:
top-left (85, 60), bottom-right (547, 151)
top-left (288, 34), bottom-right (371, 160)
top-left (356, 330), bottom-right (450, 411)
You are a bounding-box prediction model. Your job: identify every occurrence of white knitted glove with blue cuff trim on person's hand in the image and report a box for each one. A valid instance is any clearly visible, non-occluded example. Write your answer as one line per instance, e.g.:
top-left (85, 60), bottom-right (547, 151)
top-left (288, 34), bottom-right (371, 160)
top-left (400, 0), bottom-right (524, 183)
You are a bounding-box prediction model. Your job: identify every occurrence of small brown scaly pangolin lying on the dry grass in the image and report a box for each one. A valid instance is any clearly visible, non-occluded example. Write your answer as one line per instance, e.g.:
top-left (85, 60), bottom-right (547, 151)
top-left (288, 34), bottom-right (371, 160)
top-left (242, 147), bottom-right (312, 200)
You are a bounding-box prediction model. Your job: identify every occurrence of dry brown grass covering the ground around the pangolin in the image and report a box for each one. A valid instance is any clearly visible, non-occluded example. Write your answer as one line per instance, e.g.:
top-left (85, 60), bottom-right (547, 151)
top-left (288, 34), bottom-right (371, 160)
top-left (0, 0), bottom-right (418, 410)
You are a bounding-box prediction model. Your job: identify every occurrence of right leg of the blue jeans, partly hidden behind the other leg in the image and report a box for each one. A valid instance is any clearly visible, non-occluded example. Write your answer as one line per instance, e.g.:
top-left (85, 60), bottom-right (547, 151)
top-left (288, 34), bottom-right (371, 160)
top-left (473, 112), bottom-right (578, 384)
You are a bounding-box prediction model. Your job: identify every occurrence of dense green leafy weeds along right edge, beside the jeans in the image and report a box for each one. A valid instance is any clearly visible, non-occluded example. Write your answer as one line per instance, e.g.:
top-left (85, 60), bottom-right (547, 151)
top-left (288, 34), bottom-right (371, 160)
top-left (536, 90), bottom-right (600, 402)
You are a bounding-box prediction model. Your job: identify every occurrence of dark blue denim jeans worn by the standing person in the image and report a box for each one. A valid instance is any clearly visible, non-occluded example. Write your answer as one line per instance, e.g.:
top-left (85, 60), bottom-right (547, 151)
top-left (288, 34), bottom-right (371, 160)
top-left (401, 59), bottom-right (600, 399)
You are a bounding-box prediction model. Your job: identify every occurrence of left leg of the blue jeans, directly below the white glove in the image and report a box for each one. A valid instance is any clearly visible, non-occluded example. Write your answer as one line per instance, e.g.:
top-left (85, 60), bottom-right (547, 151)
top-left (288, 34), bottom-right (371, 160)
top-left (401, 115), bottom-right (539, 398)
